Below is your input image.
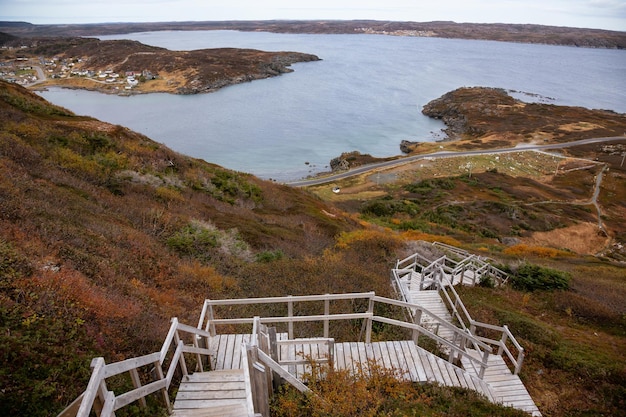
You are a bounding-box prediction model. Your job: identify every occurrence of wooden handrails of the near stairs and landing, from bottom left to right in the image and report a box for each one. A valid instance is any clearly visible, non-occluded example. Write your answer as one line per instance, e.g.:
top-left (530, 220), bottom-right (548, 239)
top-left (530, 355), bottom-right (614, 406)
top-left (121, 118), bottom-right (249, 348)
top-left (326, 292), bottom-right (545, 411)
top-left (59, 286), bottom-right (523, 417)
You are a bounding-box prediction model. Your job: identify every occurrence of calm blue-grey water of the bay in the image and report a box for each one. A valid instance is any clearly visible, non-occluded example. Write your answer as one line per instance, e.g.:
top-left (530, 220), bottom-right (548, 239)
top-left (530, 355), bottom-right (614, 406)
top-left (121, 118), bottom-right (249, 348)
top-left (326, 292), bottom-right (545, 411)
top-left (41, 31), bottom-right (626, 181)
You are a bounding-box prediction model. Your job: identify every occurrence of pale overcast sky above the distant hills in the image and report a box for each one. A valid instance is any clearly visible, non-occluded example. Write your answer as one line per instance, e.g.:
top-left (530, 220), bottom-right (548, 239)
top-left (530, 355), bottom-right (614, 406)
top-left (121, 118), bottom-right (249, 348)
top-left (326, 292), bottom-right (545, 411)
top-left (0, 0), bottom-right (626, 31)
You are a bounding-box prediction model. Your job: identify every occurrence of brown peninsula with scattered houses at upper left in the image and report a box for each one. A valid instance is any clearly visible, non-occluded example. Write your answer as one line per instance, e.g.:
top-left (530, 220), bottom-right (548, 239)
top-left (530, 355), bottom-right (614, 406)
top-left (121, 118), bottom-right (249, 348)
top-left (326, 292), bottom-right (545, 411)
top-left (0, 35), bottom-right (319, 94)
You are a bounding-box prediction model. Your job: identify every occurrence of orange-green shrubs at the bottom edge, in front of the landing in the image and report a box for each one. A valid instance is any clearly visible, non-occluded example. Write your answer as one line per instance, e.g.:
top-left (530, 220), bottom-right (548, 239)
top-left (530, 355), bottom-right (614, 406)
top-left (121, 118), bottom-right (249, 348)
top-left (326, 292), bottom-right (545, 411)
top-left (271, 361), bottom-right (527, 417)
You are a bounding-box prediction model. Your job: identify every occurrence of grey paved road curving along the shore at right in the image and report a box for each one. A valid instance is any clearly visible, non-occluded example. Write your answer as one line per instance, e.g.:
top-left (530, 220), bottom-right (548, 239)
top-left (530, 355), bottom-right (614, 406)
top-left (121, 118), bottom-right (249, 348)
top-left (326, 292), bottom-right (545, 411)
top-left (286, 136), bottom-right (626, 187)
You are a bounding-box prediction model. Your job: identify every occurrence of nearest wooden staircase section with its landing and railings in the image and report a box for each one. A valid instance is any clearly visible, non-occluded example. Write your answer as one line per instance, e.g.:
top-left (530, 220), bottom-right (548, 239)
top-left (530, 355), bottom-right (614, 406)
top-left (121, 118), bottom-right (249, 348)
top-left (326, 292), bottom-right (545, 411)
top-left (59, 290), bottom-right (541, 417)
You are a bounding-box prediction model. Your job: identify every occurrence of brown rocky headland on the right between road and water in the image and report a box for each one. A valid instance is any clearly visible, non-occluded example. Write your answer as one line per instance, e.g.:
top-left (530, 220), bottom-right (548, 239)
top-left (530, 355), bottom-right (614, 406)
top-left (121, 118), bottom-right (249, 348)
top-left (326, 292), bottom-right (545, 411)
top-left (330, 87), bottom-right (626, 172)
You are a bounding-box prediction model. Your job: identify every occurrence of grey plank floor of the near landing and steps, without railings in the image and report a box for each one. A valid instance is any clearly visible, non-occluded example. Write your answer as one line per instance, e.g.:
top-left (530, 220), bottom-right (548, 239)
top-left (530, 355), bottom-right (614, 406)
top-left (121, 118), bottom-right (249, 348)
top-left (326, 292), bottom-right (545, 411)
top-left (190, 334), bottom-right (541, 417)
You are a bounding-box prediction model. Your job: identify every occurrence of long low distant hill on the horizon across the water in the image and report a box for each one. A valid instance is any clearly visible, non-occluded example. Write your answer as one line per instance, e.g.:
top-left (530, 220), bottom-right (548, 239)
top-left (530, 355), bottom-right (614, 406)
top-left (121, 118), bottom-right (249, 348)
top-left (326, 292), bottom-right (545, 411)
top-left (0, 20), bottom-right (626, 49)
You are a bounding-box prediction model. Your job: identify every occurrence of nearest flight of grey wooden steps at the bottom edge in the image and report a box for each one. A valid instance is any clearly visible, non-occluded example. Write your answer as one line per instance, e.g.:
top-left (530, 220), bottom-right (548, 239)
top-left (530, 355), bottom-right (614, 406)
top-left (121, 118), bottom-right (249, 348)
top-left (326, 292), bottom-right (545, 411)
top-left (172, 369), bottom-right (248, 417)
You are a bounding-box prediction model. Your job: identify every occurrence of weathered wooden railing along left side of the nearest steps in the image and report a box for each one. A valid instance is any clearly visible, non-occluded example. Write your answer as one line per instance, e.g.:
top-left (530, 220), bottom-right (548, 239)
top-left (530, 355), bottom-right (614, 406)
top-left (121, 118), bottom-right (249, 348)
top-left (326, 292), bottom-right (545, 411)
top-left (58, 318), bottom-right (211, 417)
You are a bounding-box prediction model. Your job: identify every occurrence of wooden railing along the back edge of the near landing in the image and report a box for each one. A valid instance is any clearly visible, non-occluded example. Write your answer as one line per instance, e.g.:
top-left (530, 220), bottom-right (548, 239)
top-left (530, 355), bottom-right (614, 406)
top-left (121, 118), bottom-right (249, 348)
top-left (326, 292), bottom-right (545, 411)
top-left (199, 292), bottom-right (492, 378)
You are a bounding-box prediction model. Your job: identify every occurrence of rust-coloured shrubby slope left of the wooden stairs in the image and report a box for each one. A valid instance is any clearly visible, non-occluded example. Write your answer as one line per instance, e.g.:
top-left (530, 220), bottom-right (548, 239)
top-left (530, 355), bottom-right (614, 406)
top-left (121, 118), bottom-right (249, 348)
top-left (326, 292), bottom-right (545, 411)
top-left (0, 82), bottom-right (371, 415)
